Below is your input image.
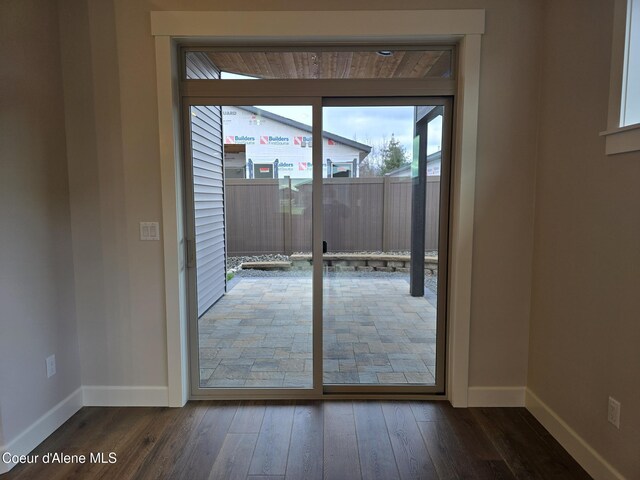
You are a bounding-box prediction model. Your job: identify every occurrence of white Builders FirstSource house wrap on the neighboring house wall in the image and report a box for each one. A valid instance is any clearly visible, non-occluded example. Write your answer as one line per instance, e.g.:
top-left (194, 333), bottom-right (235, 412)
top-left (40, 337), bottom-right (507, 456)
top-left (222, 107), bottom-right (366, 178)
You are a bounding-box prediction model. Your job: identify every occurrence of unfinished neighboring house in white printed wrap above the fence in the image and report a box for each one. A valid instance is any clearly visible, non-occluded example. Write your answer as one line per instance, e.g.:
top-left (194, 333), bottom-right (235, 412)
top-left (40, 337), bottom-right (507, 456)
top-left (222, 106), bottom-right (371, 178)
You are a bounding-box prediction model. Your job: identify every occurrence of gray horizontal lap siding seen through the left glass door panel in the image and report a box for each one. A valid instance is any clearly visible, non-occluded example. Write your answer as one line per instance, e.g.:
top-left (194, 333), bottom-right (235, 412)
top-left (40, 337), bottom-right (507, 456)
top-left (191, 106), bottom-right (226, 317)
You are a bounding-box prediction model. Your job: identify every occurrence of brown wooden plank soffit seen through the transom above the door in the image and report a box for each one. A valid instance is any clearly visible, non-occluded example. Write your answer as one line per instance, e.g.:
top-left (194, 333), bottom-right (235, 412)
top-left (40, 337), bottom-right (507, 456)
top-left (207, 49), bottom-right (452, 79)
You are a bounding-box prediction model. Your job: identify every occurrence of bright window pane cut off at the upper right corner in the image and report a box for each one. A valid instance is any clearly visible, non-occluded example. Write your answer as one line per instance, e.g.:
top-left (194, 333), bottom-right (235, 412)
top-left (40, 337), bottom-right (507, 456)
top-left (620, 0), bottom-right (640, 127)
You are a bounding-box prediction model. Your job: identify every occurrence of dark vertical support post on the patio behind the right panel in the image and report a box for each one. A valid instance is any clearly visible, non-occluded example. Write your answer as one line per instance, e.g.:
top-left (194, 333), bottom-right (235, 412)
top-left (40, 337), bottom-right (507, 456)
top-left (409, 120), bottom-right (427, 297)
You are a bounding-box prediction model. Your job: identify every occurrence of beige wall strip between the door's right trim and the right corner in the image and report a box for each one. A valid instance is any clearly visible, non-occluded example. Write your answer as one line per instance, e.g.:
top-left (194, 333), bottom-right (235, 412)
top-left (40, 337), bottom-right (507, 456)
top-left (462, 1), bottom-right (541, 386)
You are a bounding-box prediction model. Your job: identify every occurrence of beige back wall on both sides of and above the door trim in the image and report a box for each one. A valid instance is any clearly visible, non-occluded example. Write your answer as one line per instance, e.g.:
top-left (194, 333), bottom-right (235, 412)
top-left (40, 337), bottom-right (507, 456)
top-left (60, 0), bottom-right (540, 392)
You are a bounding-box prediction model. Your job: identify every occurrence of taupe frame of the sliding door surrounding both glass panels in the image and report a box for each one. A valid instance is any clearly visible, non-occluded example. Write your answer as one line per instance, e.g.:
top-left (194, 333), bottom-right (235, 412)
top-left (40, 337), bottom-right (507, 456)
top-left (182, 94), bottom-right (454, 399)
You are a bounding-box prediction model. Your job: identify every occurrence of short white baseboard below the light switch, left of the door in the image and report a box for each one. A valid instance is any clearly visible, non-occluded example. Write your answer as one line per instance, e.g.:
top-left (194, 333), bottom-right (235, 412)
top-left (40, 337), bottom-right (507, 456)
top-left (82, 385), bottom-right (169, 407)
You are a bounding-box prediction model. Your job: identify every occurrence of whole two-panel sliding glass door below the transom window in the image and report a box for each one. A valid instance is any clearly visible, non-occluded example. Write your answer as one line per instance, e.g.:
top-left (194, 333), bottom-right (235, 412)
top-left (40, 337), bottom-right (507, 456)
top-left (184, 97), bottom-right (451, 398)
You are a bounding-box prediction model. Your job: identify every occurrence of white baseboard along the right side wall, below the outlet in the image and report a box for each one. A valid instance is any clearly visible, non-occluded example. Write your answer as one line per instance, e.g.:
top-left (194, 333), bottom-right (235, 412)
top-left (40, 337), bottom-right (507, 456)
top-left (525, 389), bottom-right (624, 480)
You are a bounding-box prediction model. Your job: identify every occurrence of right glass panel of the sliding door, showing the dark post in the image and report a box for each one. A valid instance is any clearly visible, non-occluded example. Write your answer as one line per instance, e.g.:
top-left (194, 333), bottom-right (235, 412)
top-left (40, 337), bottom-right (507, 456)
top-left (322, 100), bottom-right (448, 392)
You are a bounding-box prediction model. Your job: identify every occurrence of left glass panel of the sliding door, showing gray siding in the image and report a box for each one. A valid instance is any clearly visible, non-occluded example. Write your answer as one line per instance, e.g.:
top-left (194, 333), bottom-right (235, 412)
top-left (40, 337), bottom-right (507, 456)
top-left (185, 104), bottom-right (313, 394)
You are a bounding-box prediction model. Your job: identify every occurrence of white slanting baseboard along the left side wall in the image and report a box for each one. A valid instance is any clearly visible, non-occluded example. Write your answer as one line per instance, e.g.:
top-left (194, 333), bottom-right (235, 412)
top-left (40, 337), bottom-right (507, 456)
top-left (0, 388), bottom-right (82, 474)
